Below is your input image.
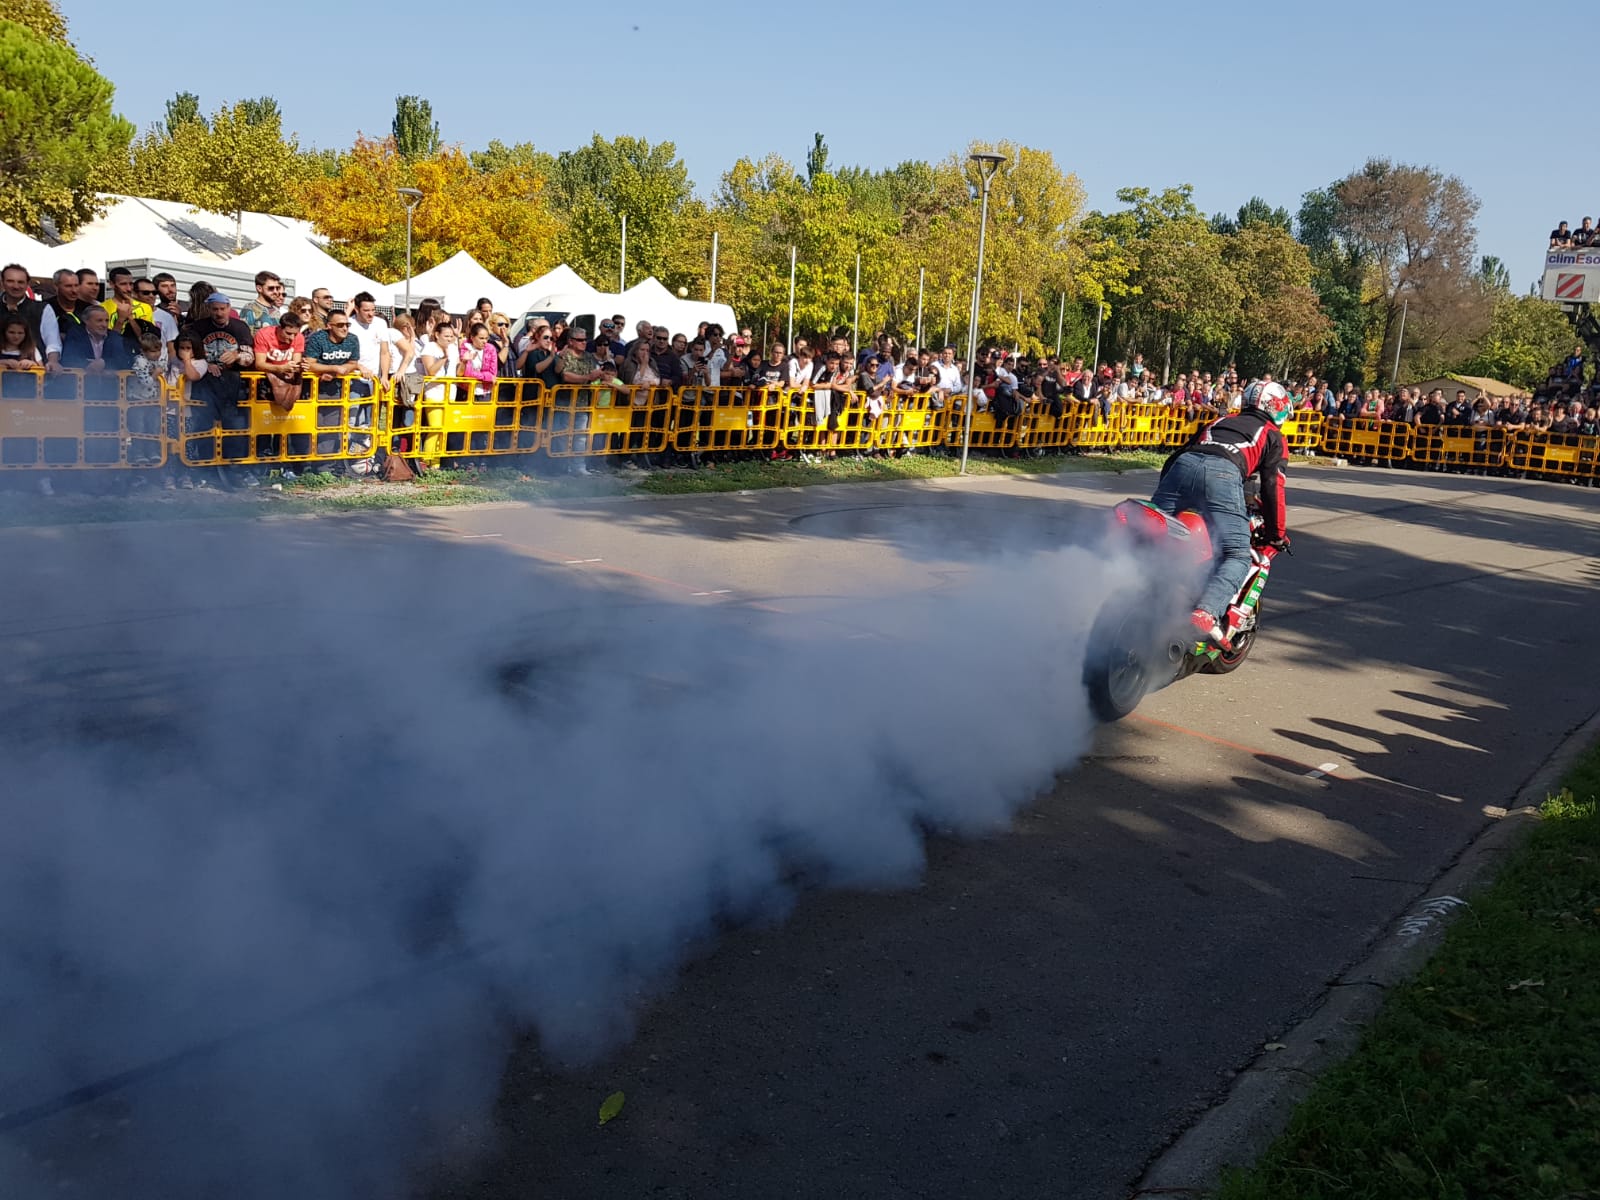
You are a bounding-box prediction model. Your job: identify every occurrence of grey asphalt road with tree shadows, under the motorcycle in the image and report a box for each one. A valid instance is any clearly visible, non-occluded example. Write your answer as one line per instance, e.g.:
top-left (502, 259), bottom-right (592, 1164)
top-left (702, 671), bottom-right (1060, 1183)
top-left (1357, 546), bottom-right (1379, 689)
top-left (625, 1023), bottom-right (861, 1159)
top-left (0, 469), bottom-right (1600, 1200)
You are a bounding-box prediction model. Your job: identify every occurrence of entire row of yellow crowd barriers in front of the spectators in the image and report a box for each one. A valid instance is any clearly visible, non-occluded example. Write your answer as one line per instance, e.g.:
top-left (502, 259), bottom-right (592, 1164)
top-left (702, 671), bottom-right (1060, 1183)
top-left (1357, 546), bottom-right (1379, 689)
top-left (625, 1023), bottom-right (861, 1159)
top-left (9, 370), bottom-right (1600, 482)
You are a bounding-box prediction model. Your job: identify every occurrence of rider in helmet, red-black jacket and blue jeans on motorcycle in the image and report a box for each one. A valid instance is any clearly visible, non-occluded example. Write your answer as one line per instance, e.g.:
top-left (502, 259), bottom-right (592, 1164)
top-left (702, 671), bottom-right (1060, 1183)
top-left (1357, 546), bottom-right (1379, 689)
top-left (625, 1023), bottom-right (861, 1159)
top-left (1150, 381), bottom-right (1293, 648)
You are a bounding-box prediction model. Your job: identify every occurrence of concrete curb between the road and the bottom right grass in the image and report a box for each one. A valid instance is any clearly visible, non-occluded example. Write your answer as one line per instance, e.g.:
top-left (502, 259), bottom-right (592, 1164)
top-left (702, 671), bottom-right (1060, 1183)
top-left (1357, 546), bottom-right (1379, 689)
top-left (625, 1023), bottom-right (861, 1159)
top-left (1130, 712), bottom-right (1600, 1200)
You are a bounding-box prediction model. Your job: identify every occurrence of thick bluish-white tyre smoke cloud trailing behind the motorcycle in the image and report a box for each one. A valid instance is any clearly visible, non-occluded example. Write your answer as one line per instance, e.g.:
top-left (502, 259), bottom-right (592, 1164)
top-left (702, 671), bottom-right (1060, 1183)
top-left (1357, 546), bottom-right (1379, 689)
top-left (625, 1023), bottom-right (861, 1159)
top-left (0, 514), bottom-right (1110, 1200)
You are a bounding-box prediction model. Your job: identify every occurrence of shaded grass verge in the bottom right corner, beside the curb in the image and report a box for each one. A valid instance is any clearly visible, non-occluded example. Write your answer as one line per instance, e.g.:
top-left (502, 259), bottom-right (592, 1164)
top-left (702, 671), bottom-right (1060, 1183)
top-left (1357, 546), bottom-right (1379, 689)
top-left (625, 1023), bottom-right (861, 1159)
top-left (1218, 746), bottom-right (1600, 1200)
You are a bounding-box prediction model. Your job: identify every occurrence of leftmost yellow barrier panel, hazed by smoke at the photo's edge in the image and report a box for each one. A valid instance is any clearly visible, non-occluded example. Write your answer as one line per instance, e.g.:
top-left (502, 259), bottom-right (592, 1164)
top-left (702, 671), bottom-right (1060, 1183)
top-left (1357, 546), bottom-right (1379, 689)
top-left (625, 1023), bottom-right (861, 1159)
top-left (0, 371), bottom-right (166, 470)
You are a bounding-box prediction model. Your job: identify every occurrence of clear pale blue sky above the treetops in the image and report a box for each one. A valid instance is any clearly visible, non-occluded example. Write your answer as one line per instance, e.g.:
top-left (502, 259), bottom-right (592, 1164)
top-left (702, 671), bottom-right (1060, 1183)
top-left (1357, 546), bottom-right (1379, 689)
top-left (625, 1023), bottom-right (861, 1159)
top-left (62, 0), bottom-right (1568, 290)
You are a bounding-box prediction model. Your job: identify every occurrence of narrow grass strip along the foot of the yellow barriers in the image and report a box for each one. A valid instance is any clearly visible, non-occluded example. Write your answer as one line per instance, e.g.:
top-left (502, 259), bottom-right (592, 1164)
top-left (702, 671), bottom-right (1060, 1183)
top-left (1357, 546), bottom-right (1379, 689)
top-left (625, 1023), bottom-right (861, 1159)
top-left (0, 450), bottom-right (1168, 526)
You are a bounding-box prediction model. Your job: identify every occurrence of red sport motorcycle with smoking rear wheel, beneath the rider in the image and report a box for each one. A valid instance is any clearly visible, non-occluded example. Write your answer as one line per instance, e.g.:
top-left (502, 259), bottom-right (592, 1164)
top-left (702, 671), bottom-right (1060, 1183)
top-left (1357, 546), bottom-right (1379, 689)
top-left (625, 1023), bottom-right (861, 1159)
top-left (1083, 480), bottom-right (1283, 722)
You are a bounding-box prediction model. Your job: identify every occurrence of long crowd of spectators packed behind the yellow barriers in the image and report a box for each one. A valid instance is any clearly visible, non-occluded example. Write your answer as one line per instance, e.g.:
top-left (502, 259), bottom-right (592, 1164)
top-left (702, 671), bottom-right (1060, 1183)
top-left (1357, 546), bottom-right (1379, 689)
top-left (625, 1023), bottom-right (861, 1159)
top-left (0, 256), bottom-right (1600, 490)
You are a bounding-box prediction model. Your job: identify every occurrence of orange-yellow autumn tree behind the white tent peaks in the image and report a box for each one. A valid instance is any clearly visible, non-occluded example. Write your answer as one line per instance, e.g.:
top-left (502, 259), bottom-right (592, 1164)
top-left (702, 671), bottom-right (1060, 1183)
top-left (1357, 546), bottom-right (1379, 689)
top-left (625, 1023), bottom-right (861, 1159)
top-left (299, 138), bottom-right (562, 286)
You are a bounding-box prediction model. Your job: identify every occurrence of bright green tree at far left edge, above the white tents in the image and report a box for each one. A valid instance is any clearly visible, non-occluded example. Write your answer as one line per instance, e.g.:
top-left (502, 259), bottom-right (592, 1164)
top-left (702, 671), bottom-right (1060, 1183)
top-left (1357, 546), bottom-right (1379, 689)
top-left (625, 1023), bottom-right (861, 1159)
top-left (0, 21), bottom-right (133, 237)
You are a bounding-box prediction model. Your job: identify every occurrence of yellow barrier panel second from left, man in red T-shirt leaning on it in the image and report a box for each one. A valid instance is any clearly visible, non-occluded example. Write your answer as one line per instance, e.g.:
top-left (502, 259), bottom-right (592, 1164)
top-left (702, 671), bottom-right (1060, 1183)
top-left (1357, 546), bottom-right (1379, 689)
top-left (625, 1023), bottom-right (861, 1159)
top-left (173, 371), bottom-right (379, 467)
